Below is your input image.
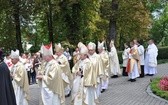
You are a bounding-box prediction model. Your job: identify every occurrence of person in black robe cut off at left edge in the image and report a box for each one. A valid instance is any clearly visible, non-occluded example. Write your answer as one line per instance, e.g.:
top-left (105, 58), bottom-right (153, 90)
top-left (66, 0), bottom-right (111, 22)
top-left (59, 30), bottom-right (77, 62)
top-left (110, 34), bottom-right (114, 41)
top-left (0, 49), bottom-right (16, 105)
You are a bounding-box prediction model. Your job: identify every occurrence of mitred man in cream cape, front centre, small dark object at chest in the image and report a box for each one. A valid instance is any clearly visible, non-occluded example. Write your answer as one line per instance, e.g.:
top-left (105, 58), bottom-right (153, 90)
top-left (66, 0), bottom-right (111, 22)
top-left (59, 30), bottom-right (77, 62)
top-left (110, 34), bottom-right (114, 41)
top-left (72, 42), bottom-right (97, 105)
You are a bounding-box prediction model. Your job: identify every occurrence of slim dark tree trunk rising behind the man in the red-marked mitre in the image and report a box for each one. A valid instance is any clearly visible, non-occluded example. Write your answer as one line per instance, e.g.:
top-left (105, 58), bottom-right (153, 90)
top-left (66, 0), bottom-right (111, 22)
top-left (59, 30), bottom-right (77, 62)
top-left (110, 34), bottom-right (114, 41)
top-left (47, 0), bottom-right (53, 44)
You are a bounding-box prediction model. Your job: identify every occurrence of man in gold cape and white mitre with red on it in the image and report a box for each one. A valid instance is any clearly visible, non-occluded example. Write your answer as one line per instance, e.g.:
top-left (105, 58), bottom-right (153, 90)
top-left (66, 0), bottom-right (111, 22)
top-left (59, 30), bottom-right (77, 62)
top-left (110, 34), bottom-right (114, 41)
top-left (36, 44), bottom-right (65, 105)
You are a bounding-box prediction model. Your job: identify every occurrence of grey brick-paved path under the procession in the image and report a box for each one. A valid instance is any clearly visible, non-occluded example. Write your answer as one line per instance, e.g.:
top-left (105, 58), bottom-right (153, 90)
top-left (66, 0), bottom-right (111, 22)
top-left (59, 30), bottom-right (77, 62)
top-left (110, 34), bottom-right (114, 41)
top-left (29, 64), bottom-right (168, 105)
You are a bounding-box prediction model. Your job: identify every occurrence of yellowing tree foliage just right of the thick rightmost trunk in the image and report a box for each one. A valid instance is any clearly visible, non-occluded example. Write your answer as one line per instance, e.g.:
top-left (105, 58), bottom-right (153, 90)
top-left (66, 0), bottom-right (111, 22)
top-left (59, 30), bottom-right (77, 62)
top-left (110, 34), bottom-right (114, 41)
top-left (118, 0), bottom-right (151, 42)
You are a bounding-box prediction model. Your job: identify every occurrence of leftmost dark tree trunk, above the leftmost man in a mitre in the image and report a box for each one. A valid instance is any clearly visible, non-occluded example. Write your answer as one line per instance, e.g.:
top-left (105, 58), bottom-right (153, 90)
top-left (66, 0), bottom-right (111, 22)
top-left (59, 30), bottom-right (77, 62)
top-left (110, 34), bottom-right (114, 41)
top-left (13, 0), bottom-right (24, 53)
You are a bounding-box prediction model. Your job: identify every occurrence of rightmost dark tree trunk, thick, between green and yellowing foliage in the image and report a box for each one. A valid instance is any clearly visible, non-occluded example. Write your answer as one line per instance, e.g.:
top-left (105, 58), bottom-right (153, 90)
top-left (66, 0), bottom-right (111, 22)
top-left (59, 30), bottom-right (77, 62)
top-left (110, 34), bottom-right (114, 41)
top-left (108, 0), bottom-right (118, 42)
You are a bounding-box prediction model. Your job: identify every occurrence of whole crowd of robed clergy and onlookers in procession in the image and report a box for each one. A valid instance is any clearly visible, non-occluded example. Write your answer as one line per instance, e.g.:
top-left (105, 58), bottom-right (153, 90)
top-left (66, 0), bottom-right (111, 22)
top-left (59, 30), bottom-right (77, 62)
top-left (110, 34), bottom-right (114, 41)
top-left (0, 40), bottom-right (158, 105)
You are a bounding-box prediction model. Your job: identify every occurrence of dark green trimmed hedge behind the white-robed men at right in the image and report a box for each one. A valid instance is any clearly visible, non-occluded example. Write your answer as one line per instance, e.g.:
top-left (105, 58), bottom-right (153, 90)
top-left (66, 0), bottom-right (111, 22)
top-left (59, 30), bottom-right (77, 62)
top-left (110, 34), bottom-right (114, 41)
top-left (118, 46), bottom-right (168, 64)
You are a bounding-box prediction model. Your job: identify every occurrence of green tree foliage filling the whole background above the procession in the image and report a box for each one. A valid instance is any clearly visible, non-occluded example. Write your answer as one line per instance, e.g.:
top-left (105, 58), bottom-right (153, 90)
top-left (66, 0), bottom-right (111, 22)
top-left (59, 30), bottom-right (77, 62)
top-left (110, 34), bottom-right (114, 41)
top-left (0, 0), bottom-right (168, 52)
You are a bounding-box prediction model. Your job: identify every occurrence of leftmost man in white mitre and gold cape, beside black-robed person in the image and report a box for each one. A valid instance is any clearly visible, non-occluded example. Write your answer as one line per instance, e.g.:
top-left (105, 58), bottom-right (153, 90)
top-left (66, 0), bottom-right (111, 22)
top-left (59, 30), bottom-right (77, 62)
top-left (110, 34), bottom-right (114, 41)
top-left (11, 50), bottom-right (29, 105)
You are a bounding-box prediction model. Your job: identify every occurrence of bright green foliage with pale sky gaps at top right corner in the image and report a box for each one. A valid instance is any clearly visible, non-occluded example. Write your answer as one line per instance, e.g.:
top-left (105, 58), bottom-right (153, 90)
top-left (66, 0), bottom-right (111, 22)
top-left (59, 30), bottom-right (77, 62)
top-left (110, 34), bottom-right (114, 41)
top-left (148, 0), bottom-right (168, 46)
